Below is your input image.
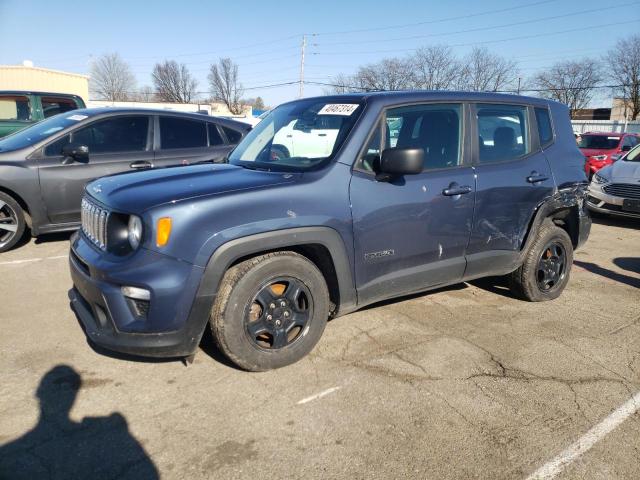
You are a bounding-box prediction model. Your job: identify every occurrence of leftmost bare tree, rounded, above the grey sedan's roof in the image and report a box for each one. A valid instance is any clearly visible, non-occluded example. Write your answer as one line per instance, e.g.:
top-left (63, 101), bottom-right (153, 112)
top-left (89, 53), bottom-right (136, 102)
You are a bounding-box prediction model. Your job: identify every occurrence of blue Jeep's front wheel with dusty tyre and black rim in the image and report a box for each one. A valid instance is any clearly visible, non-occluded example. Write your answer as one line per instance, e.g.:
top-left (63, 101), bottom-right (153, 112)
top-left (210, 252), bottom-right (329, 371)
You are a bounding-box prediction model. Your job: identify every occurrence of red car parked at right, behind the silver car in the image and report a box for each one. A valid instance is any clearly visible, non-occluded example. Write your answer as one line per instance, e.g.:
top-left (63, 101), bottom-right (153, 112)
top-left (578, 132), bottom-right (640, 178)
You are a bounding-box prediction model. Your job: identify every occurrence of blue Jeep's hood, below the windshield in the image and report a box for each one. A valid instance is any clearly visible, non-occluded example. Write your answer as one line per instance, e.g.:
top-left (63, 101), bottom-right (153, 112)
top-left (86, 164), bottom-right (301, 213)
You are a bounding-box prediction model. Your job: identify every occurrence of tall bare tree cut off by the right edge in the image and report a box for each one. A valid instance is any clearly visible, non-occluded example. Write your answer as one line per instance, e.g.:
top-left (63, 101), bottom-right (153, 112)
top-left (605, 35), bottom-right (640, 120)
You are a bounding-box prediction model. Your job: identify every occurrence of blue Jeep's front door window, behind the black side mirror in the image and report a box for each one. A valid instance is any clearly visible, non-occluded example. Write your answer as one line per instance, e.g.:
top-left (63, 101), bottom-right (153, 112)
top-left (385, 104), bottom-right (462, 170)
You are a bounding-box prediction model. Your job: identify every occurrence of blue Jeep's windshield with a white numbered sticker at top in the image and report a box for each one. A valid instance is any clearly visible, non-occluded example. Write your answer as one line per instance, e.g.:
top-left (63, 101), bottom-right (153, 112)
top-left (229, 98), bottom-right (362, 171)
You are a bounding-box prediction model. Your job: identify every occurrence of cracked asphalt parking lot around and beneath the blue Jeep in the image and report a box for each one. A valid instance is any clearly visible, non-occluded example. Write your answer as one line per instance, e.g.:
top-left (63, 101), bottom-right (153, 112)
top-left (0, 219), bottom-right (640, 479)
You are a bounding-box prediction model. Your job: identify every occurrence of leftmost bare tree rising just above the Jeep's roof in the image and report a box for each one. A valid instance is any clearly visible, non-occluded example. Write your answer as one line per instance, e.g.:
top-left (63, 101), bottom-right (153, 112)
top-left (354, 58), bottom-right (413, 90)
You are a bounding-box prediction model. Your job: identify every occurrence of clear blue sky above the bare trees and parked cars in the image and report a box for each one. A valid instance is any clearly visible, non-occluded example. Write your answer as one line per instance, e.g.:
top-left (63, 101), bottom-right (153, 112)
top-left (0, 0), bottom-right (640, 106)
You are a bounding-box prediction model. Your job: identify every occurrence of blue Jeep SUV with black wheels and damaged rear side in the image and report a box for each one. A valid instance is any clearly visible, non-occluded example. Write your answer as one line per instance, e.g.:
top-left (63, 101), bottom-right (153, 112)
top-left (70, 92), bottom-right (591, 371)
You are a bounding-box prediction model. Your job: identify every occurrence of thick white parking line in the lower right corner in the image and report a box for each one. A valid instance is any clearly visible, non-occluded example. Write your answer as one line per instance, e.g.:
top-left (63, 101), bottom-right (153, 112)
top-left (527, 392), bottom-right (640, 480)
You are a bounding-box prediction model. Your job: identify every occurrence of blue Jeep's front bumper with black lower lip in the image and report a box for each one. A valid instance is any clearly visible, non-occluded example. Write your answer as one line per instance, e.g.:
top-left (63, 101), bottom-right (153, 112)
top-left (69, 232), bottom-right (213, 357)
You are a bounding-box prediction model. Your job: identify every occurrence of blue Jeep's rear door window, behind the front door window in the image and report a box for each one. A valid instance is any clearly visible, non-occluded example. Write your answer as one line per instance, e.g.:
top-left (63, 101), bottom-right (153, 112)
top-left (477, 105), bottom-right (531, 163)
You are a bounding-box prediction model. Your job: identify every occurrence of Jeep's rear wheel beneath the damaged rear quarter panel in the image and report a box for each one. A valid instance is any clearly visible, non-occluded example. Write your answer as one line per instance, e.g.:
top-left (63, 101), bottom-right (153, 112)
top-left (510, 220), bottom-right (573, 302)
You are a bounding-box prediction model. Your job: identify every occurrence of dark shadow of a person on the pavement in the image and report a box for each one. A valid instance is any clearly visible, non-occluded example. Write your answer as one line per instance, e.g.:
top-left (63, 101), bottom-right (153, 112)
top-left (0, 365), bottom-right (159, 480)
